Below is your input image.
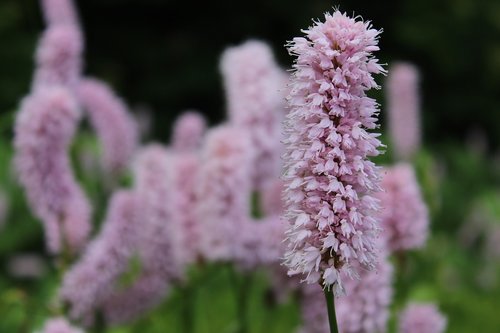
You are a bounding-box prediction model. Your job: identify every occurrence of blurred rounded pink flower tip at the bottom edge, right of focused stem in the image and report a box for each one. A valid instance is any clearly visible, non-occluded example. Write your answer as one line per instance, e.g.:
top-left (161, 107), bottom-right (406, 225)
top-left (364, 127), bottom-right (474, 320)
top-left (399, 303), bottom-right (447, 333)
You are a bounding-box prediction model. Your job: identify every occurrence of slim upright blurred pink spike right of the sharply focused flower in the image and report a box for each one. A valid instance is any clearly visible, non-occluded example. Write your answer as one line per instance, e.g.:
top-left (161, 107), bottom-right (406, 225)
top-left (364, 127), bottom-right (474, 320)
top-left (387, 62), bottom-right (421, 160)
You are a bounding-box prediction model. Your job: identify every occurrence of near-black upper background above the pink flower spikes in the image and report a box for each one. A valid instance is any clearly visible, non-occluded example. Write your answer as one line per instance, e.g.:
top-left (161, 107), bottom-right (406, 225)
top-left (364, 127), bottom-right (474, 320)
top-left (0, 0), bottom-right (500, 151)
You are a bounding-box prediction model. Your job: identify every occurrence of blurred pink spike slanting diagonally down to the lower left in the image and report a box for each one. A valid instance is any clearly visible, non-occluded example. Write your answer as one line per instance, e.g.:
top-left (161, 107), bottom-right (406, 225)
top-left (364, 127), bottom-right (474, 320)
top-left (59, 191), bottom-right (141, 323)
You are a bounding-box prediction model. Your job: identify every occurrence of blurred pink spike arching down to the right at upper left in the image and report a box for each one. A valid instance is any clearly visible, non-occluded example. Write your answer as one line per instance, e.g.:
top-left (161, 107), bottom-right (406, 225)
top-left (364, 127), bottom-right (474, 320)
top-left (78, 78), bottom-right (138, 174)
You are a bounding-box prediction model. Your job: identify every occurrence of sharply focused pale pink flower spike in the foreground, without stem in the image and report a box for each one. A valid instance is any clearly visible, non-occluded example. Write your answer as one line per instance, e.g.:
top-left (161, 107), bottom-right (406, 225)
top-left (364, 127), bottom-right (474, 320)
top-left (284, 11), bottom-right (384, 291)
